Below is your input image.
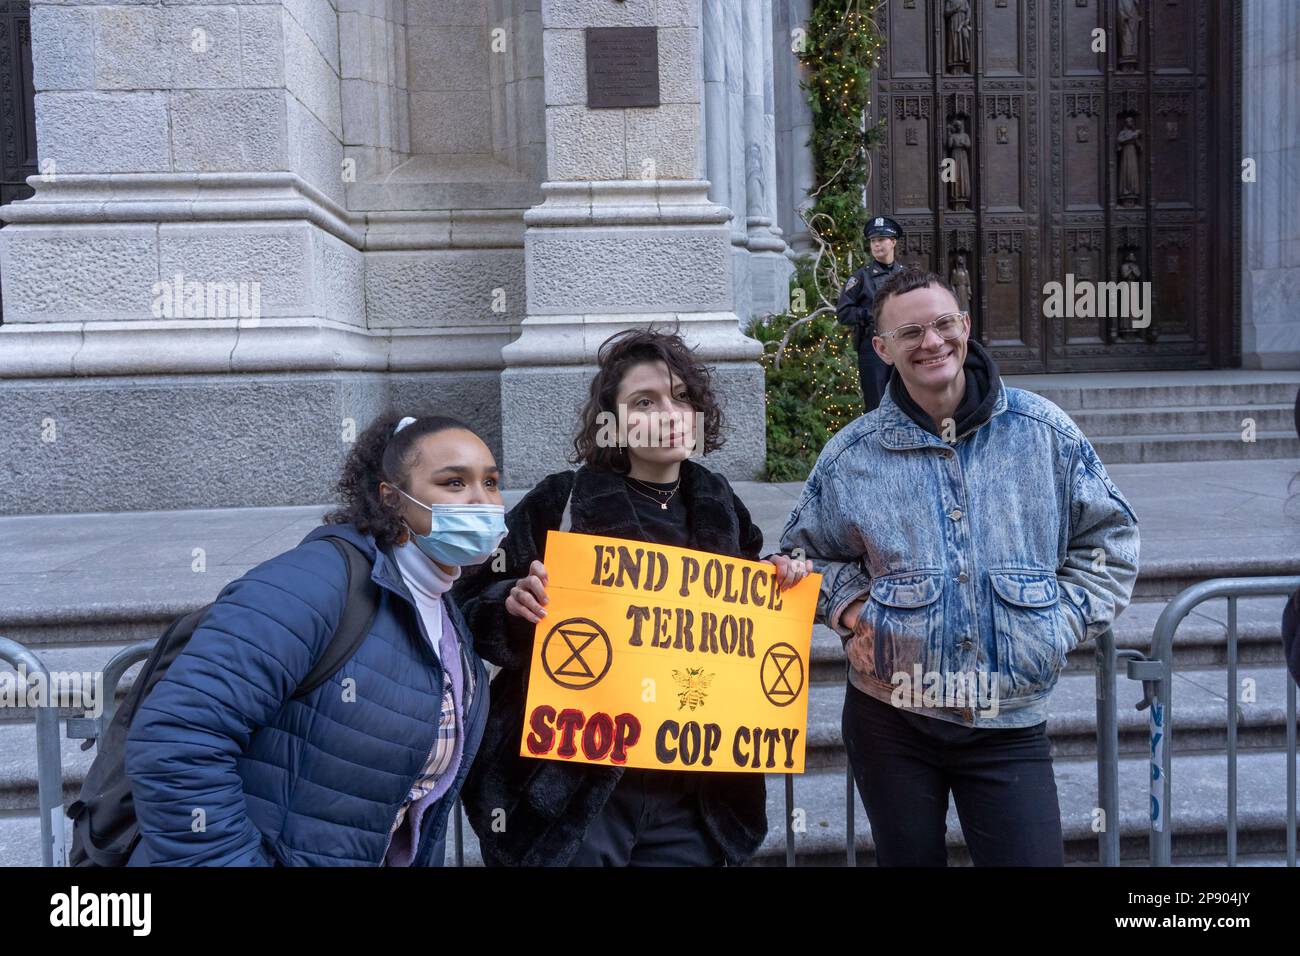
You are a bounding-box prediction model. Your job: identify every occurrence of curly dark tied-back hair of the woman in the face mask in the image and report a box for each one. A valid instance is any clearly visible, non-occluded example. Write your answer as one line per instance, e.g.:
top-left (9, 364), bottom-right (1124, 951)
top-left (325, 411), bottom-right (473, 548)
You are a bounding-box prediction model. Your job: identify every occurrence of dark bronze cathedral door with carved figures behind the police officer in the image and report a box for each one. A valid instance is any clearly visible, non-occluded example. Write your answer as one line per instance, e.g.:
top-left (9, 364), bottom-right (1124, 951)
top-left (868, 0), bottom-right (1242, 372)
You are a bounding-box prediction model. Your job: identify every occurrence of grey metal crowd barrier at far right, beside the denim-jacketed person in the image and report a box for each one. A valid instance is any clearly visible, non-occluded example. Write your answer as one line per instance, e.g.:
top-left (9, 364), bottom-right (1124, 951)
top-left (1128, 578), bottom-right (1300, 866)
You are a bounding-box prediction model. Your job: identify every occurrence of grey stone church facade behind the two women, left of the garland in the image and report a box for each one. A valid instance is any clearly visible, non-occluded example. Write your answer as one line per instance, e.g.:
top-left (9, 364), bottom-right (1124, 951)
top-left (0, 0), bottom-right (790, 512)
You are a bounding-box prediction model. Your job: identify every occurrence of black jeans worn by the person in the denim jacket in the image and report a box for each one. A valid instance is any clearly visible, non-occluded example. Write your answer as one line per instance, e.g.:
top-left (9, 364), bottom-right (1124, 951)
top-left (844, 684), bottom-right (1065, 866)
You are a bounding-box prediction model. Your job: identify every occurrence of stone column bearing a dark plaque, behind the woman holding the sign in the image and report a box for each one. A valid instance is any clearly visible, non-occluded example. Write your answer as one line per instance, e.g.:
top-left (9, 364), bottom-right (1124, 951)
top-left (501, 0), bottom-right (764, 485)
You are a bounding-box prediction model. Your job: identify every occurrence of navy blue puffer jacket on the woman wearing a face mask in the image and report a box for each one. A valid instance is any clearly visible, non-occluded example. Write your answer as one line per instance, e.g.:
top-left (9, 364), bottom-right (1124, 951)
top-left (126, 524), bottom-right (488, 866)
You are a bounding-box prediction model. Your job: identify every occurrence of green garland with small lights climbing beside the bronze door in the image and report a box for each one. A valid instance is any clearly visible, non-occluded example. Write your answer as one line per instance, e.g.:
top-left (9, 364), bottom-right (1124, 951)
top-left (753, 0), bottom-right (884, 481)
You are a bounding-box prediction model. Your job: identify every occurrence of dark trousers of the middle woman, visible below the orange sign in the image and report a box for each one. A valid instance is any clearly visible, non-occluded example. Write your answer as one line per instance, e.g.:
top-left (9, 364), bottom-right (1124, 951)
top-left (569, 769), bottom-right (725, 866)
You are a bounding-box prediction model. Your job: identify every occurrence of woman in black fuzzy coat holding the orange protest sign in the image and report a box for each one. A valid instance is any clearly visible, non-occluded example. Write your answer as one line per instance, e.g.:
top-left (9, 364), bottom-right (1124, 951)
top-left (456, 329), bottom-right (810, 866)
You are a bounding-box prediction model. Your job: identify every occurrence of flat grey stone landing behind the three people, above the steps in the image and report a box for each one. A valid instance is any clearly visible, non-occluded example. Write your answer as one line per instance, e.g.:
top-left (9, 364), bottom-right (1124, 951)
top-left (0, 459), bottom-right (1300, 624)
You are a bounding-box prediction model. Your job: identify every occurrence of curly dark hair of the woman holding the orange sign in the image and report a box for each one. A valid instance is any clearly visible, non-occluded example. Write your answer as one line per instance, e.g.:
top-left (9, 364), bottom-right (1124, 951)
top-left (569, 326), bottom-right (725, 473)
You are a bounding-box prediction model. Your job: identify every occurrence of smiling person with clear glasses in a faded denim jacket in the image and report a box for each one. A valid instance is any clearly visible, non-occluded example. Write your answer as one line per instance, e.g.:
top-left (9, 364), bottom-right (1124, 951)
top-left (781, 267), bottom-right (1138, 866)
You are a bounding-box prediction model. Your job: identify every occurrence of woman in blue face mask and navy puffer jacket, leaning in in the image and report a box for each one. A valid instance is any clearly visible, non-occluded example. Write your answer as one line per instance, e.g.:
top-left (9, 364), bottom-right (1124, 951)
top-left (126, 415), bottom-right (506, 866)
